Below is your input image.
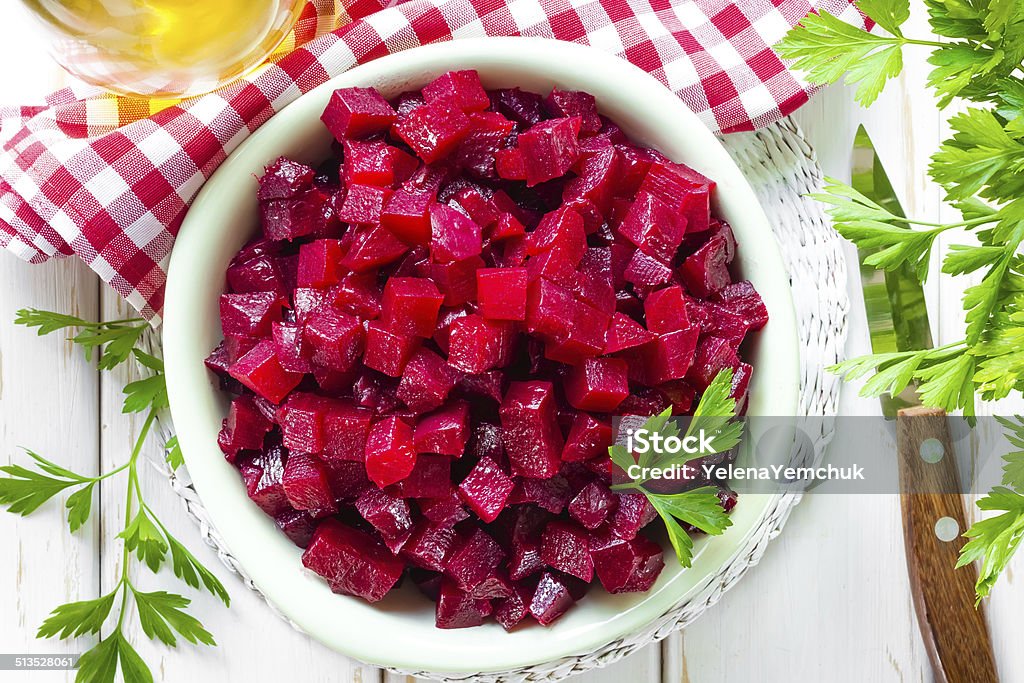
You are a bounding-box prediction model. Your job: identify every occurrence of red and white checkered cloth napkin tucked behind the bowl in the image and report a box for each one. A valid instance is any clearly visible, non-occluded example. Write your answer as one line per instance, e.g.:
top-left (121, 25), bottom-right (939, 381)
top-left (0, 0), bottom-right (863, 324)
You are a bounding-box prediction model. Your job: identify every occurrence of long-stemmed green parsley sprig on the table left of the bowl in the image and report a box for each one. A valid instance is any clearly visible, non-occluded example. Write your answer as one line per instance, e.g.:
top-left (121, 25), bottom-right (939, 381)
top-left (0, 309), bottom-right (230, 683)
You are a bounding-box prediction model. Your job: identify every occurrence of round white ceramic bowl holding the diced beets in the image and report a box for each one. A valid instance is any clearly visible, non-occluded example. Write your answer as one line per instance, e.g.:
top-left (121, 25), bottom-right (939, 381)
top-left (164, 38), bottom-right (799, 673)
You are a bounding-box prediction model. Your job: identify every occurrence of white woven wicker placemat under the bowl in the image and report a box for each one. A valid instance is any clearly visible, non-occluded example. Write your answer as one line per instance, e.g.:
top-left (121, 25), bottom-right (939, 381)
top-left (148, 119), bottom-right (849, 683)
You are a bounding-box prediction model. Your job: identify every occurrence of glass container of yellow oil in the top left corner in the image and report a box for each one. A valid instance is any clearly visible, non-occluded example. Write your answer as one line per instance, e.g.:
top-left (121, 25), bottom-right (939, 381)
top-left (23, 0), bottom-right (305, 98)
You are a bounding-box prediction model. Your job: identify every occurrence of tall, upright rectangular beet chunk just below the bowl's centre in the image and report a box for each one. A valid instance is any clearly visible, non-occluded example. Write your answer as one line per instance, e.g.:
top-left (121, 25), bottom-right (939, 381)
top-left (501, 381), bottom-right (563, 478)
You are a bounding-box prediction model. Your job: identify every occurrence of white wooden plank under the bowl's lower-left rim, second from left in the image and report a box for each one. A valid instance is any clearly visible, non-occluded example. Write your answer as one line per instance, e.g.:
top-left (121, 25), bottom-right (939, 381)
top-left (100, 288), bottom-right (380, 683)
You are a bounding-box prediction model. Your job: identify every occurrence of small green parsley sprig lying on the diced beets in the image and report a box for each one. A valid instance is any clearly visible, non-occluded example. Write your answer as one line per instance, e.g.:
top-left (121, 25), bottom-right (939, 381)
top-left (608, 369), bottom-right (743, 567)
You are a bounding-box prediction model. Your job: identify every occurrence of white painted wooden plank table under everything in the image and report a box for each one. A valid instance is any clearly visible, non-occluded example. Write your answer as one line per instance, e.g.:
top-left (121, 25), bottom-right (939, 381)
top-left (0, 3), bottom-right (1024, 683)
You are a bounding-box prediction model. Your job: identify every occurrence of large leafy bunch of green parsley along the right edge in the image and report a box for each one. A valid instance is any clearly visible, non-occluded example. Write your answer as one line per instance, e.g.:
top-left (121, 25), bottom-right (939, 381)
top-left (776, 0), bottom-right (1024, 599)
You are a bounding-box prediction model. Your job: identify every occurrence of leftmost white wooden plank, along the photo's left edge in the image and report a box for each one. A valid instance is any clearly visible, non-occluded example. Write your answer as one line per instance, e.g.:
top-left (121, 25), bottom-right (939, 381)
top-left (0, 256), bottom-right (99, 682)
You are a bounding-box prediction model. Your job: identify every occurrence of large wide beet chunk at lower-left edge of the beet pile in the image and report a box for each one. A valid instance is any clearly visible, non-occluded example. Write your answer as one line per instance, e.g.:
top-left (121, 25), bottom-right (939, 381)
top-left (302, 519), bottom-right (404, 602)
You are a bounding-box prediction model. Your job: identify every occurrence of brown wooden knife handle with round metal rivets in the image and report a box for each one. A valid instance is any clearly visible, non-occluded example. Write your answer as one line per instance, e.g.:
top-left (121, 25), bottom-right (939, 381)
top-left (896, 408), bottom-right (998, 683)
